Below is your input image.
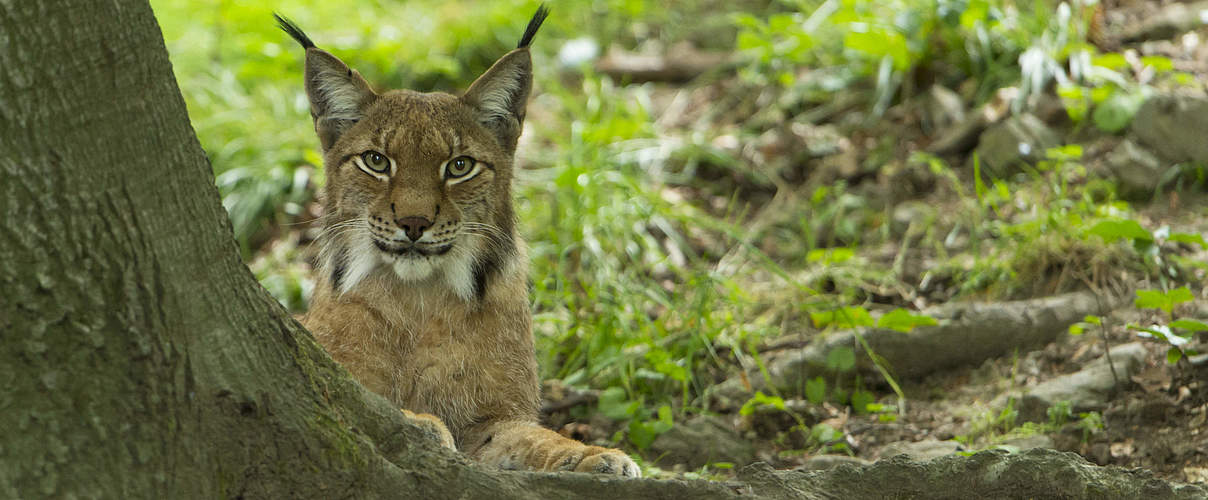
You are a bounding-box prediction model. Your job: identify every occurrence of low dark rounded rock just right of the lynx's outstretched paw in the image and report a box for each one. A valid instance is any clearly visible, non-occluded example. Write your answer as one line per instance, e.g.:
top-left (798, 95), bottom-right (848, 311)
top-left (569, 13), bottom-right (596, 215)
top-left (647, 415), bottom-right (755, 467)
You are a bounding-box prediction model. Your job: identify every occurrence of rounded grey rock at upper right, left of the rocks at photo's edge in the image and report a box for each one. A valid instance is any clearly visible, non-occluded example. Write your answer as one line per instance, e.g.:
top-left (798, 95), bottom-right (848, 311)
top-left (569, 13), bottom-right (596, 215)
top-left (970, 114), bottom-right (1061, 176)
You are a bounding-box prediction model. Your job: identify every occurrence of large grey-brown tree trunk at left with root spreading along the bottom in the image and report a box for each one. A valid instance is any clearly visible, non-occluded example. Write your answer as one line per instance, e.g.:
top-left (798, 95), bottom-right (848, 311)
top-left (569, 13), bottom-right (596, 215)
top-left (0, 0), bottom-right (1202, 499)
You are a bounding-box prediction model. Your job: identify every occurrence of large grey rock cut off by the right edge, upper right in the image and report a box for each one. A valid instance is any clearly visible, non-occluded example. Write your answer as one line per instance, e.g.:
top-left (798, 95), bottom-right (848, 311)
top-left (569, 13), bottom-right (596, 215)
top-left (1131, 94), bottom-right (1208, 163)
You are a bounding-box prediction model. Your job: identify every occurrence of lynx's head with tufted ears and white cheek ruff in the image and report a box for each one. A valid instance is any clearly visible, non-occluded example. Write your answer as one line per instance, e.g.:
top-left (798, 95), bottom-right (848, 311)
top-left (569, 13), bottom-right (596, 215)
top-left (277, 6), bottom-right (548, 301)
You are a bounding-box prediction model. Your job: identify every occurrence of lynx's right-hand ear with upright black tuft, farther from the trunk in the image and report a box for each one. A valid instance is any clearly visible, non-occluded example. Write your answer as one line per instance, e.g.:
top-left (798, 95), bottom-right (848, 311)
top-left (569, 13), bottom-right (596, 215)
top-left (461, 5), bottom-right (550, 150)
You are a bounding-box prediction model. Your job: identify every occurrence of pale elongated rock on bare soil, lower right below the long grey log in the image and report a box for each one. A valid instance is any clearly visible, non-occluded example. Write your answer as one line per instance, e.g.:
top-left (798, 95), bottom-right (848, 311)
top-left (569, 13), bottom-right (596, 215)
top-left (1014, 342), bottom-right (1149, 421)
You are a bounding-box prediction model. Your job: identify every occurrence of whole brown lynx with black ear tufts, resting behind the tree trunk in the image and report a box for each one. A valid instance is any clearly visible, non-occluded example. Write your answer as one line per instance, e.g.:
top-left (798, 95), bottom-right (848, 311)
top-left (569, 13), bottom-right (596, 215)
top-left (278, 7), bottom-right (640, 477)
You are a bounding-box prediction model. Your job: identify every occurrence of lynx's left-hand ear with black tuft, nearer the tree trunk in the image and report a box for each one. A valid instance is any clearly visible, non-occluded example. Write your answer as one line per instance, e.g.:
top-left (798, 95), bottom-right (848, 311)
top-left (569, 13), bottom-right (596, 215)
top-left (273, 13), bottom-right (377, 151)
